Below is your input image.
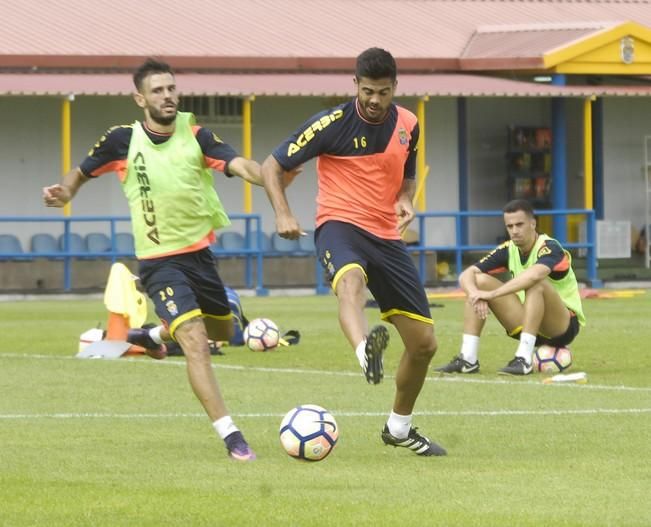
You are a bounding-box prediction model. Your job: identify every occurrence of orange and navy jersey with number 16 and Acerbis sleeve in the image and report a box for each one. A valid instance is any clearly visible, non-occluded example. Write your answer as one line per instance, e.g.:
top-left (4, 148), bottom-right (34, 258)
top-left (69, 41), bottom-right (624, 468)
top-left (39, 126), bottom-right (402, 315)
top-left (272, 99), bottom-right (419, 239)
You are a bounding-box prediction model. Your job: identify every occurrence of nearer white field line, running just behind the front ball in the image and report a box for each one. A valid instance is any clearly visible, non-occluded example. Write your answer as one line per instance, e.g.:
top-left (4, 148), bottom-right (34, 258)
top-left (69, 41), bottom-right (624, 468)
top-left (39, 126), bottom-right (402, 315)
top-left (0, 408), bottom-right (651, 421)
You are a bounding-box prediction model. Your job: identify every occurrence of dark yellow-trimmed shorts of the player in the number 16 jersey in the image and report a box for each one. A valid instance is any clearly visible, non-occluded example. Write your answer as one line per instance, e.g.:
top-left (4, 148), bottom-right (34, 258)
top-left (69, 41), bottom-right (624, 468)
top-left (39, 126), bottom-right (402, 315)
top-left (315, 220), bottom-right (433, 324)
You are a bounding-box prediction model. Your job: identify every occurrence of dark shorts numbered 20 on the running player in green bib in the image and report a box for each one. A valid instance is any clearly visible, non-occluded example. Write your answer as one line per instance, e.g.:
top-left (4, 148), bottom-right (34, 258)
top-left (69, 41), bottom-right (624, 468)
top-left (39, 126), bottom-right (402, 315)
top-left (139, 248), bottom-right (231, 336)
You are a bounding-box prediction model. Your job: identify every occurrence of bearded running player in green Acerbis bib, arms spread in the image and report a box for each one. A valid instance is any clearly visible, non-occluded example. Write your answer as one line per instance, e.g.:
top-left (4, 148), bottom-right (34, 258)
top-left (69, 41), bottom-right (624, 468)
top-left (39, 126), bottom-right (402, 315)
top-left (43, 59), bottom-right (282, 461)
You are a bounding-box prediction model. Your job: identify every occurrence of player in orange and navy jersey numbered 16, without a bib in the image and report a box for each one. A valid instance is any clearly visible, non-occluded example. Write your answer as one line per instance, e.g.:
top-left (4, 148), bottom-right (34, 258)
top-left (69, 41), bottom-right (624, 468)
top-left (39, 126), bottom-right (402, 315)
top-left (262, 48), bottom-right (446, 456)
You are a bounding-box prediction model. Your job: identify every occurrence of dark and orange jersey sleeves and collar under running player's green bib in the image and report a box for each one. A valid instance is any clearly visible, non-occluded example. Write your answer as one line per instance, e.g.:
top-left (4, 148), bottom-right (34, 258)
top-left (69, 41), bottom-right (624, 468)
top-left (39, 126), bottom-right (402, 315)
top-left (79, 123), bottom-right (238, 181)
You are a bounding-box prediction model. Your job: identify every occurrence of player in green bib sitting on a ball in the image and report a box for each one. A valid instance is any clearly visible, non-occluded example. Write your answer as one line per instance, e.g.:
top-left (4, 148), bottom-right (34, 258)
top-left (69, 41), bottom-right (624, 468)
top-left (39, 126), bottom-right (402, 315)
top-left (436, 200), bottom-right (585, 375)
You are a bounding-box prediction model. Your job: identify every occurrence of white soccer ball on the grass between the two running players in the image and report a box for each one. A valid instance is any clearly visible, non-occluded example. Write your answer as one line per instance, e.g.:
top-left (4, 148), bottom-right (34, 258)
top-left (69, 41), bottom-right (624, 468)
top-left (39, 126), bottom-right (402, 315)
top-left (280, 404), bottom-right (339, 461)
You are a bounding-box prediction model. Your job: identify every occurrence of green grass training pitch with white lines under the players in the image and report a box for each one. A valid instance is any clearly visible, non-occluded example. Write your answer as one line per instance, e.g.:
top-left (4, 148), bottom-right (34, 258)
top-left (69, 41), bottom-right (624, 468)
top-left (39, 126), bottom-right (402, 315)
top-left (0, 293), bottom-right (651, 527)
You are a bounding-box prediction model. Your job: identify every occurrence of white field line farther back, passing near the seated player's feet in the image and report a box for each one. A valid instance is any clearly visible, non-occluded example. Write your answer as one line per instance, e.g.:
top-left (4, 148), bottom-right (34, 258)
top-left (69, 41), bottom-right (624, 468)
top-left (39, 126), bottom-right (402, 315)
top-left (0, 353), bottom-right (651, 392)
